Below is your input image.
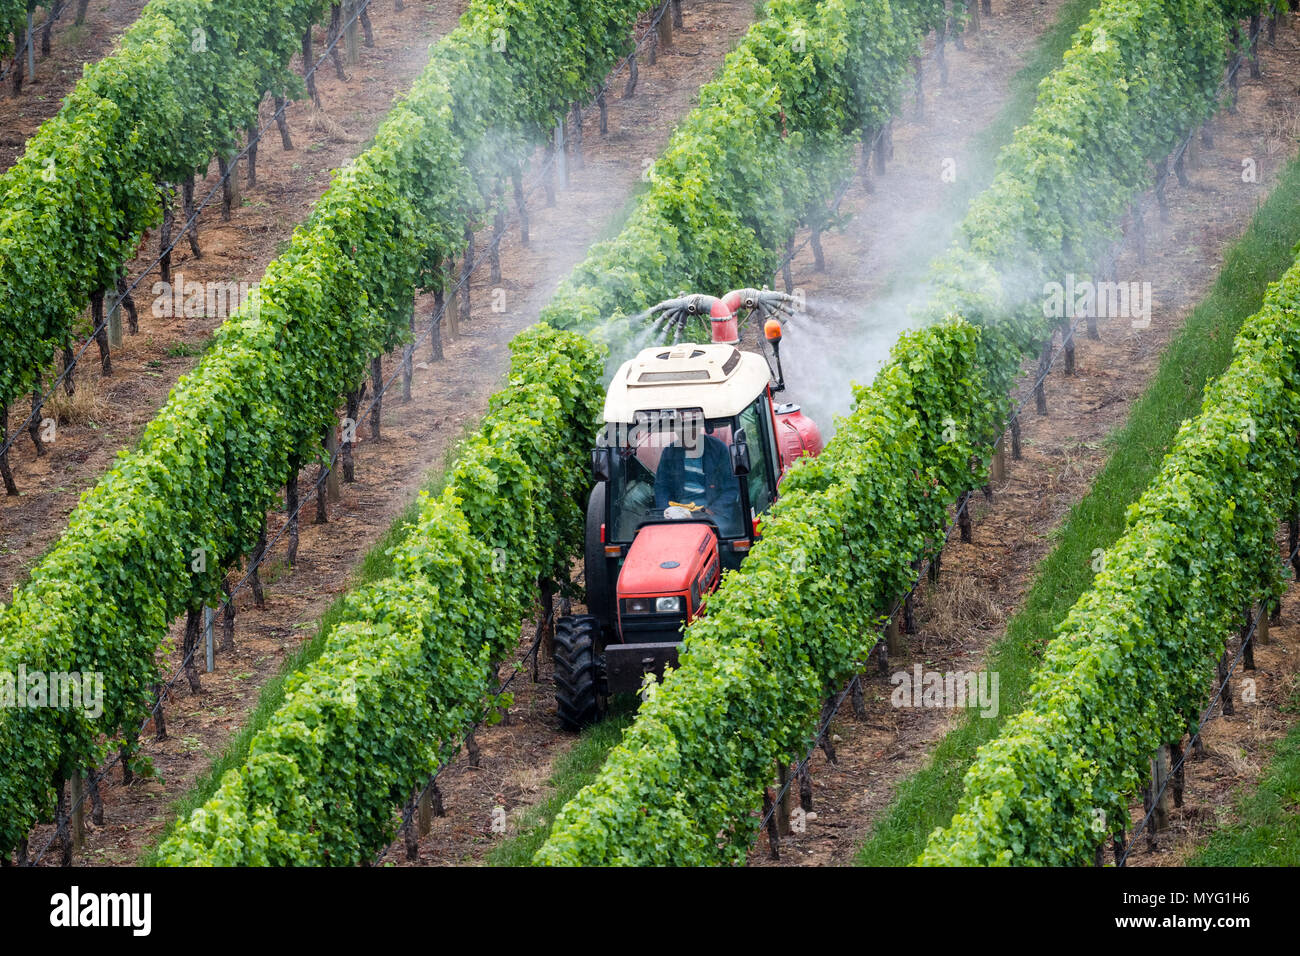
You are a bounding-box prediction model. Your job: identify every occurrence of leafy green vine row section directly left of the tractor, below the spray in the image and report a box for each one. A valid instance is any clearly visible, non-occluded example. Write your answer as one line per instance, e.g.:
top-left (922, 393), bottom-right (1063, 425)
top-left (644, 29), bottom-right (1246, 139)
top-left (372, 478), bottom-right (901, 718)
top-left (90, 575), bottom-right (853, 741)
top-left (160, 325), bottom-right (602, 866)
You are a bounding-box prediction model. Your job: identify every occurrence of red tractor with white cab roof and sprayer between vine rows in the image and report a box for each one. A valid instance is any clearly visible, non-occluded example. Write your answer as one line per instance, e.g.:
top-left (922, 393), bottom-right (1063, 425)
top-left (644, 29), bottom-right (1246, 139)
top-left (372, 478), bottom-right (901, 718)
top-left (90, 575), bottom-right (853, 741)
top-left (555, 289), bottom-right (822, 730)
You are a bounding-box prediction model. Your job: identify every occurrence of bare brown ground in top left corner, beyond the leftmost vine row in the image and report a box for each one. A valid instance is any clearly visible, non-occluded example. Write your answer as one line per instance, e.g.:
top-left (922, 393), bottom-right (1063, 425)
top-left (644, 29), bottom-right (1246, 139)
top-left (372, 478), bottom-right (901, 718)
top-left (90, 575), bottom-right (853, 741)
top-left (0, 0), bottom-right (148, 172)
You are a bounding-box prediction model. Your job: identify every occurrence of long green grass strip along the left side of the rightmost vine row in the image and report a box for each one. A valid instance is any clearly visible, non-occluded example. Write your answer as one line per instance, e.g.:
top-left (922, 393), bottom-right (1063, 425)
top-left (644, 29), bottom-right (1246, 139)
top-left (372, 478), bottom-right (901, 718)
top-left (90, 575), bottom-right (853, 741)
top-left (857, 155), bottom-right (1300, 866)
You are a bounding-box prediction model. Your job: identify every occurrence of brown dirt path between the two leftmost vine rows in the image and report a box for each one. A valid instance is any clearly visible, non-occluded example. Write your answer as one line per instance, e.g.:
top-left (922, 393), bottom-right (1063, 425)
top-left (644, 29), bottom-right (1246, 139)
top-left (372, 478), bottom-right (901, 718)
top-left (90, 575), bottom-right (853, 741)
top-left (0, 0), bottom-right (464, 594)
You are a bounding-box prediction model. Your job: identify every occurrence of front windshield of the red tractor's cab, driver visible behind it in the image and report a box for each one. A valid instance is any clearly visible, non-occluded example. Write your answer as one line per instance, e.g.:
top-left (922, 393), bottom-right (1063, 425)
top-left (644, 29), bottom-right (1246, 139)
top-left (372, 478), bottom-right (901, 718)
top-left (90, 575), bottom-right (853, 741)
top-left (608, 410), bottom-right (749, 542)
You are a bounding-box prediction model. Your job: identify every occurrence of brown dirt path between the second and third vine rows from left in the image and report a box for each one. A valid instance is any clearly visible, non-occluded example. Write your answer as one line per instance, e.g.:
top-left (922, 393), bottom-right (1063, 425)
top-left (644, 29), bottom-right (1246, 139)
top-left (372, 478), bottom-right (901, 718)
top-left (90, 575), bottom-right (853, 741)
top-left (22, 0), bottom-right (754, 864)
